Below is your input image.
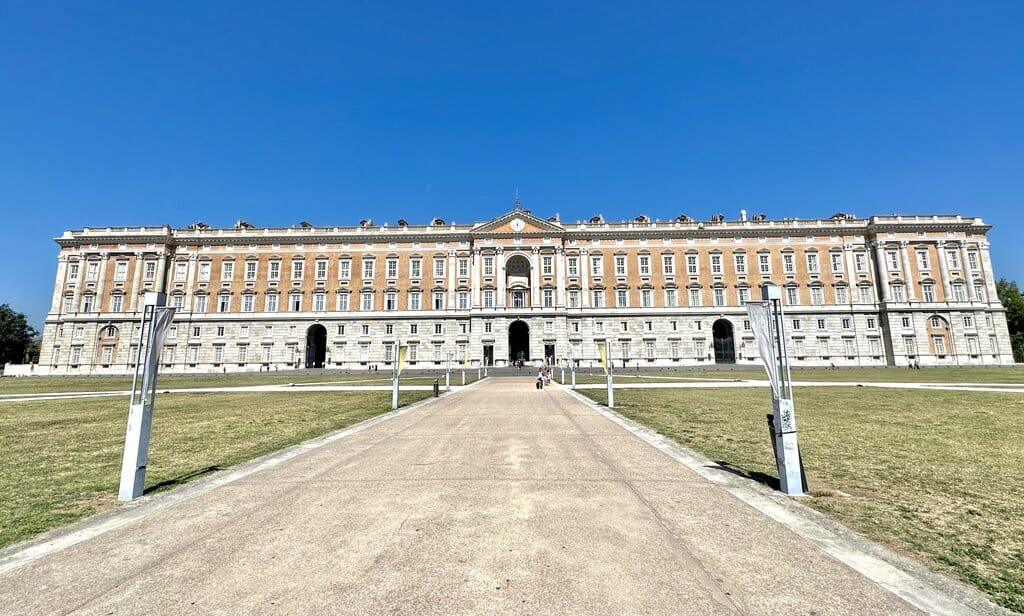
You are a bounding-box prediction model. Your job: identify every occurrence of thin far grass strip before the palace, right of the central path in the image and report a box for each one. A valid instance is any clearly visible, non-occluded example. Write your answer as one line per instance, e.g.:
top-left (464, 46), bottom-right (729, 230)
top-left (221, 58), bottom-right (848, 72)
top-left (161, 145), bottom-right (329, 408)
top-left (569, 366), bottom-right (1024, 385)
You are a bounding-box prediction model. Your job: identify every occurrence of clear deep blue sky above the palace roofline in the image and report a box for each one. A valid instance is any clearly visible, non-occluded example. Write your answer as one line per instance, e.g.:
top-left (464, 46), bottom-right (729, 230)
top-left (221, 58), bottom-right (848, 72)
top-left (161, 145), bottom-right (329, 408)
top-left (0, 0), bottom-right (1024, 326)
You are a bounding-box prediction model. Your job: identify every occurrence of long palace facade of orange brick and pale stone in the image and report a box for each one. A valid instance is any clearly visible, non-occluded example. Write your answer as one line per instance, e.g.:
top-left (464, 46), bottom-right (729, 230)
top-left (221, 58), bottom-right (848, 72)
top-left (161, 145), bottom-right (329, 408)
top-left (37, 206), bottom-right (1013, 375)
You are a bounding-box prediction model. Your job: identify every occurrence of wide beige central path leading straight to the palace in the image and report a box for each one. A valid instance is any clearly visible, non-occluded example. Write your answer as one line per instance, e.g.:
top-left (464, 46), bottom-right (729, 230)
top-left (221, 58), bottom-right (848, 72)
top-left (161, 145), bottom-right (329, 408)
top-left (0, 377), bottom-right (983, 615)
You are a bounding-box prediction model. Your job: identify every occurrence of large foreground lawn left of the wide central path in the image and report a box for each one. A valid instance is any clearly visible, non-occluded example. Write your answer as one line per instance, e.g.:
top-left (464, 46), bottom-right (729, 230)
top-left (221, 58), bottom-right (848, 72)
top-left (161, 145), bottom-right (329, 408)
top-left (0, 391), bottom-right (430, 546)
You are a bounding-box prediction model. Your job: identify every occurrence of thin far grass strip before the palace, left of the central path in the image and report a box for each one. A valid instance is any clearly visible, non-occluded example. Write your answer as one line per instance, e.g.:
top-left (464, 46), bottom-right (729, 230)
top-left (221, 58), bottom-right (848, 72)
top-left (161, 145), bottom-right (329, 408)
top-left (0, 368), bottom-right (476, 397)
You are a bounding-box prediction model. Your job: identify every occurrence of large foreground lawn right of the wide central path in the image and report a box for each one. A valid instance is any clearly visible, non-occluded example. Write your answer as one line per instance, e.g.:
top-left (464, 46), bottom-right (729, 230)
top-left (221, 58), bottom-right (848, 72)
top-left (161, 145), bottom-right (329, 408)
top-left (582, 384), bottom-right (1024, 612)
